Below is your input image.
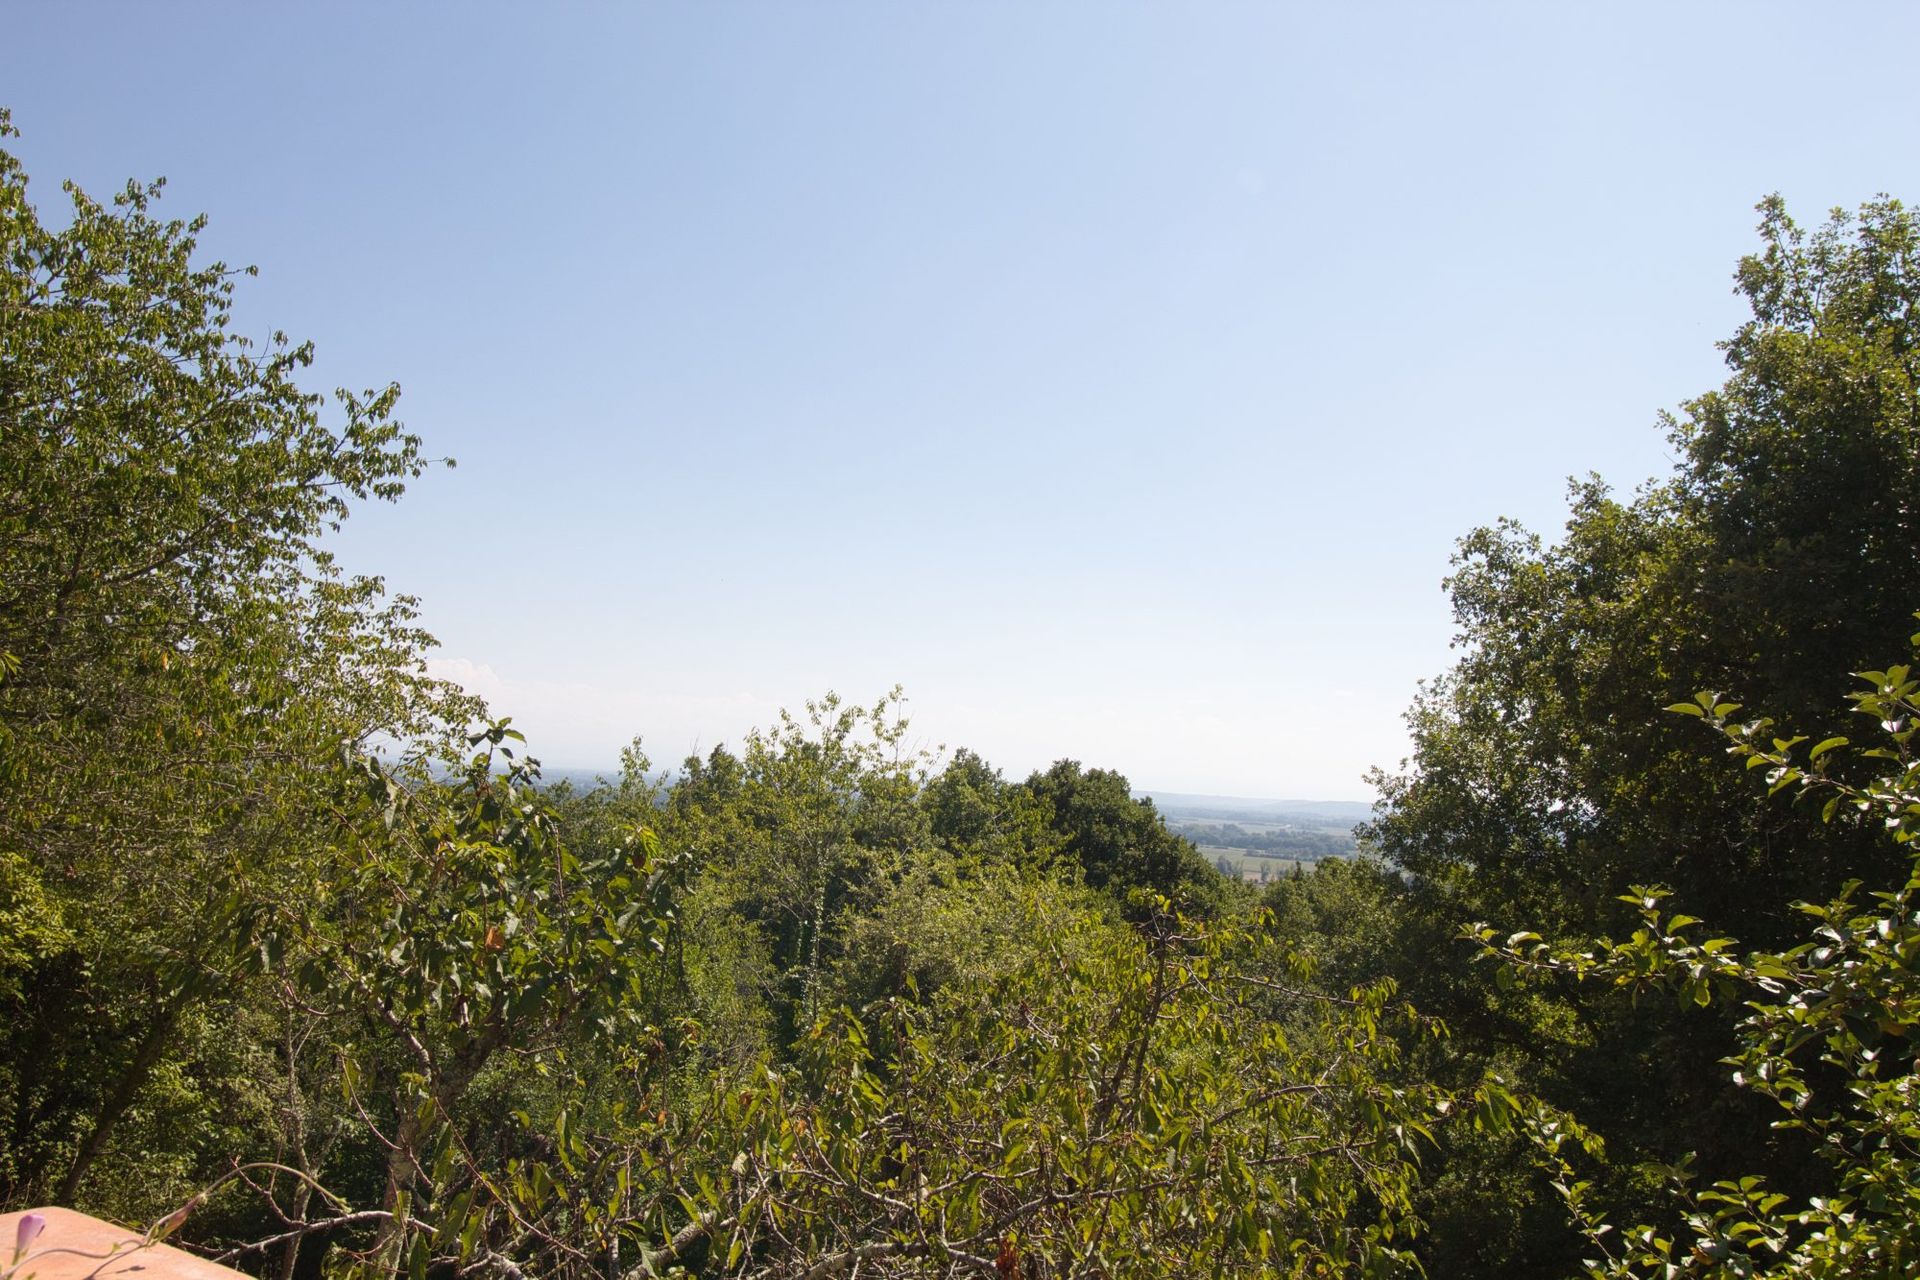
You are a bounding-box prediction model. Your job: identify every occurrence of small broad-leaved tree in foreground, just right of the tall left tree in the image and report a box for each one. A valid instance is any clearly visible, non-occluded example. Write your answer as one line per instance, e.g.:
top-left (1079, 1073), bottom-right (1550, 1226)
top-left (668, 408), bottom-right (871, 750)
top-left (236, 725), bottom-right (680, 1268)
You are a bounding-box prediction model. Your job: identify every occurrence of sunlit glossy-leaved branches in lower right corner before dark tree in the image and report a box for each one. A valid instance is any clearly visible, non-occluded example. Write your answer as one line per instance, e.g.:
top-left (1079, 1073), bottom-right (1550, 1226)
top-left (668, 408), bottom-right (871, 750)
top-left (1469, 635), bottom-right (1920, 1280)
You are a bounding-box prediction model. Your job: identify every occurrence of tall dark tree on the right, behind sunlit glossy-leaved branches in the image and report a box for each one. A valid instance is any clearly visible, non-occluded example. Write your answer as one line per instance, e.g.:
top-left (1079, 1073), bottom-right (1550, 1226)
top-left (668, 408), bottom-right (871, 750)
top-left (1367, 200), bottom-right (1920, 1268)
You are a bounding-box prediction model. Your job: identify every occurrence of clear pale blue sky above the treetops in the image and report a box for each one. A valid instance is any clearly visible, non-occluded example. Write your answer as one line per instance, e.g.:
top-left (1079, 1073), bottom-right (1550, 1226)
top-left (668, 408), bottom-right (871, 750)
top-left (0, 0), bottom-right (1920, 798)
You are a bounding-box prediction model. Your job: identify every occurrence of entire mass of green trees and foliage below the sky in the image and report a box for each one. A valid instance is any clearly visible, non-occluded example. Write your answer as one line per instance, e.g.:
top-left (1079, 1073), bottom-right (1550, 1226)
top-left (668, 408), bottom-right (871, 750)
top-left (0, 115), bottom-right (1920, 1280)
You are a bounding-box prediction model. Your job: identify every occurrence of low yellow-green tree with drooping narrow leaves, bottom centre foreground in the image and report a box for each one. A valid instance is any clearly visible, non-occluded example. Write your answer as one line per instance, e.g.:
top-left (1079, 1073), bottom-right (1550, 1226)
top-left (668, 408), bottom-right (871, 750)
top-left (589, 892), bottom-right (1519, 1280)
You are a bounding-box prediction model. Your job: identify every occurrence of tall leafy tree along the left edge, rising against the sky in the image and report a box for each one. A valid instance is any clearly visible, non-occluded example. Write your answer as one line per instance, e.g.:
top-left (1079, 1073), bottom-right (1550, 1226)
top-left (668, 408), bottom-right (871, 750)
top-left (0, 105), bottom-right (470, 1203)
